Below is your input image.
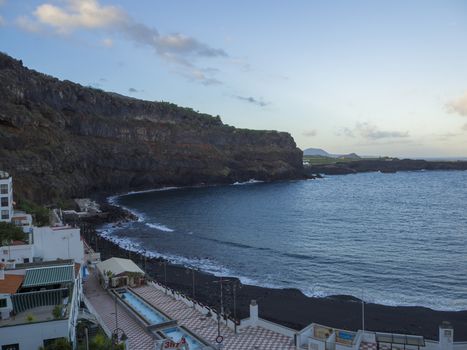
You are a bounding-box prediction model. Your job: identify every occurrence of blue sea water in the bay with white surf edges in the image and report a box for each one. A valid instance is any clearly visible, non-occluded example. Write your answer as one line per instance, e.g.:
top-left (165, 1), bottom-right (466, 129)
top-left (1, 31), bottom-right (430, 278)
top-left (102, 171), bottom-right (467, 310)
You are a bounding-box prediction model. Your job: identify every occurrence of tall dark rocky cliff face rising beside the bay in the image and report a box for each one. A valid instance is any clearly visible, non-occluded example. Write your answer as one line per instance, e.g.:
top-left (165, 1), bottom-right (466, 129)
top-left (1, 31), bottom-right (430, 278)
top-left (0, 54), bottom-right (303, 202)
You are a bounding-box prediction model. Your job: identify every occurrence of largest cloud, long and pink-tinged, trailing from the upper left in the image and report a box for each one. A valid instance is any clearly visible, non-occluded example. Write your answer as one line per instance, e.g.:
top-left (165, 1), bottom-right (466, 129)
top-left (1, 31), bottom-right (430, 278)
top-left (19, 0), bottom-right (228, 85)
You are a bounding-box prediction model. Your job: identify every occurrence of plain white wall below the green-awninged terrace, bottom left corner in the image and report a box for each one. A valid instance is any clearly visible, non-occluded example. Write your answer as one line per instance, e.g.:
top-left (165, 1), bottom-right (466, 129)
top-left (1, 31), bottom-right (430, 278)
top-left (0, 319), bottom-right (69, 350)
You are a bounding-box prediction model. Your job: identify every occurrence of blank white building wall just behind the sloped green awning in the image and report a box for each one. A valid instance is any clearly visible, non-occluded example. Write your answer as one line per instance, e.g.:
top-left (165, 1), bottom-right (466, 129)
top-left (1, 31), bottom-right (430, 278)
top-left (33, 226), bottom-right (84, 264)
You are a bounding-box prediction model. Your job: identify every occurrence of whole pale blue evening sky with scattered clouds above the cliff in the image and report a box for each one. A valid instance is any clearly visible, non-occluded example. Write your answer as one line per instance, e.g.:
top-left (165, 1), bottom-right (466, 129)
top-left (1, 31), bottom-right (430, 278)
top-left (0, 0), bottom-right (467, 157)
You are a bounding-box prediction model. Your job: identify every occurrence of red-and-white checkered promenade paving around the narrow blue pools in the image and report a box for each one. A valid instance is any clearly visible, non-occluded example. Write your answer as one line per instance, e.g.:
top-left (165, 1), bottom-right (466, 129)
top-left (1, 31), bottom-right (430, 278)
top-left (84, 266), bottom-right (295, 350)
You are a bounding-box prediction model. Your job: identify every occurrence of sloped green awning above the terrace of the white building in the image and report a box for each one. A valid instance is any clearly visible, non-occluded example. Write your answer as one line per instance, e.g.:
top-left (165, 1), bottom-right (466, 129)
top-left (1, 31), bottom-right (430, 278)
top-left (23, 265), bottom-right (74, 288)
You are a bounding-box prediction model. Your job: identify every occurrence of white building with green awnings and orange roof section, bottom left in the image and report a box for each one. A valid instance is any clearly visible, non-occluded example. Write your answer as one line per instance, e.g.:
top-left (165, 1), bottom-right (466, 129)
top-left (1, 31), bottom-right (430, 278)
top-left (0, 260), bottom-right (82, 350)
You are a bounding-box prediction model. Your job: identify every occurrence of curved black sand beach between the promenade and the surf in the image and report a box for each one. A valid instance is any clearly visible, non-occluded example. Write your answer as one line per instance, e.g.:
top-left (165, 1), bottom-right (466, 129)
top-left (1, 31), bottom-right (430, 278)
top-left (77, 201), bottom-right (467, 341)
